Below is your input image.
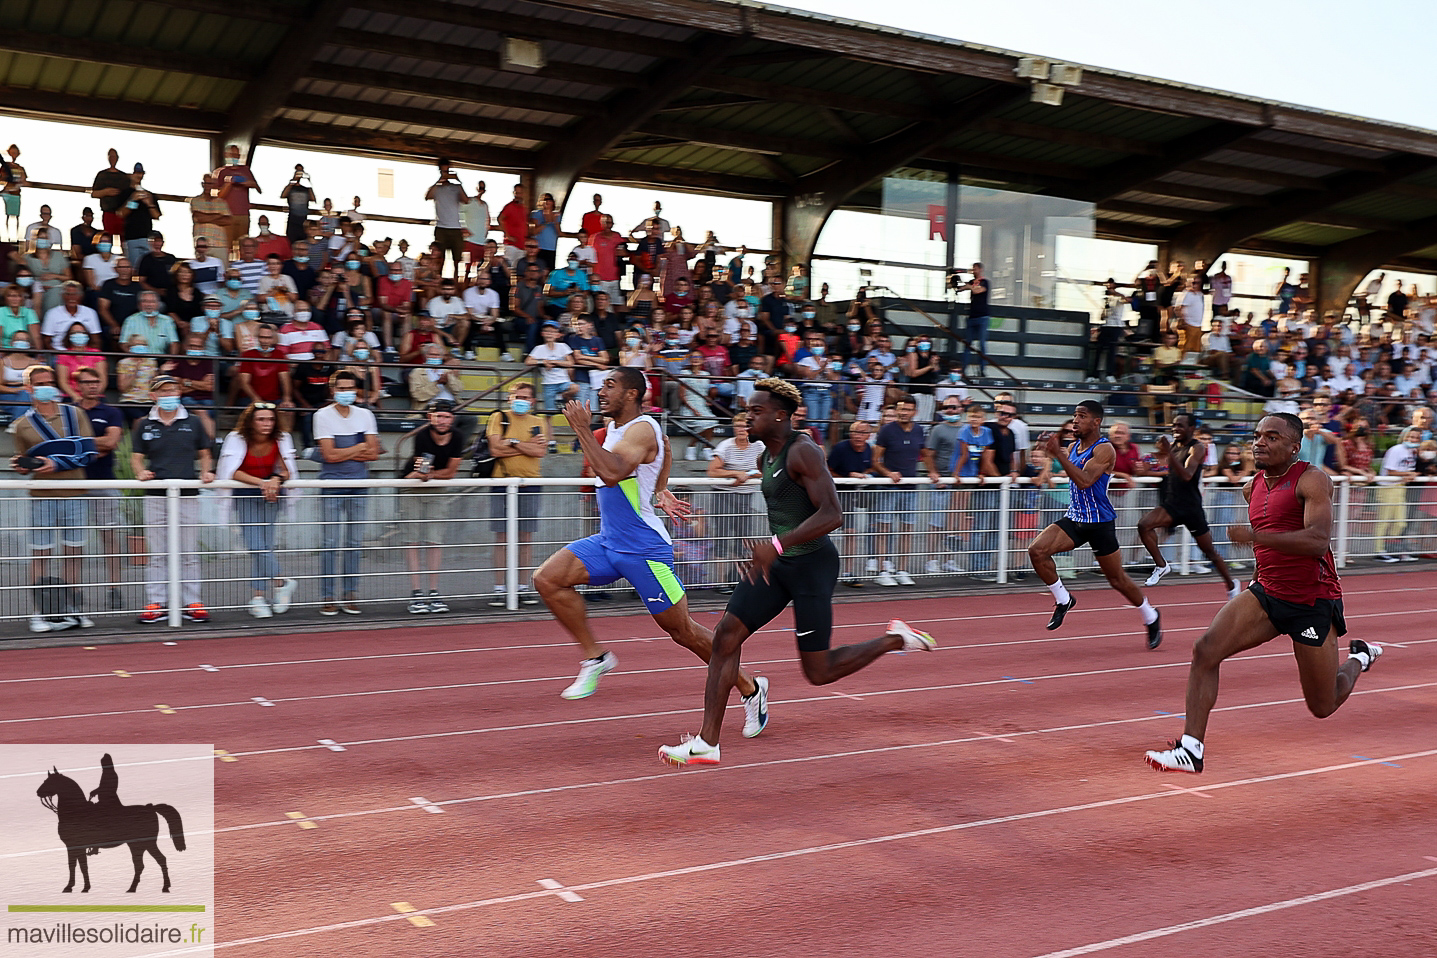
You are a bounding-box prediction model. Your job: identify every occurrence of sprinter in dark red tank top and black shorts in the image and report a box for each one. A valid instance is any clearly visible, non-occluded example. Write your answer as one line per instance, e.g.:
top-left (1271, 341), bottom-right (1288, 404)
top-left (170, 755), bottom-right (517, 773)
top-left (1147, 412), bottom-right (1382, 774)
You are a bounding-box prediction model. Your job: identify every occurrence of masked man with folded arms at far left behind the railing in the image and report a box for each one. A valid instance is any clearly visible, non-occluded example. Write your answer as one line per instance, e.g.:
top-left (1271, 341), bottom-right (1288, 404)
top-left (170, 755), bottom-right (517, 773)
top-left (10, 365), bottom-right (96, 632)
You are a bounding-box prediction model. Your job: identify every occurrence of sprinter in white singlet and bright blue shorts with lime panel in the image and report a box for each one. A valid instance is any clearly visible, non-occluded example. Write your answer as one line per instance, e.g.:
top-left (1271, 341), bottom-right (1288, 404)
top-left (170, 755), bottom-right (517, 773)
top-left (535, 366), bottom-right (767, 726)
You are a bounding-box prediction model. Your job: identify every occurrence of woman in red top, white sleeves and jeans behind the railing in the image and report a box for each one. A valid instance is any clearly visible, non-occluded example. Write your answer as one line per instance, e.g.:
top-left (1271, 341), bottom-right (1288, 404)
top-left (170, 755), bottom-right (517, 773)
top-left (217, 402), bottom-right (299, 619)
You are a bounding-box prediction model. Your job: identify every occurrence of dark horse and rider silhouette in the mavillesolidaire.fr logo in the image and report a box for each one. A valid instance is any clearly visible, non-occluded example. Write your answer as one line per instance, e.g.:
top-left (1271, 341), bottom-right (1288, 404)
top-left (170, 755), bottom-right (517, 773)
top-left (34, 753), bottom-right (184, 892)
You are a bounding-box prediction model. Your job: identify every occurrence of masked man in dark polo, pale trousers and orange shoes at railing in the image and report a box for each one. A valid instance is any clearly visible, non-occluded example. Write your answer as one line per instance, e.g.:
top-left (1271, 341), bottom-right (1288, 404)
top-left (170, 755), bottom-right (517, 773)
top-left (131, 376), bottom-right (214, 625)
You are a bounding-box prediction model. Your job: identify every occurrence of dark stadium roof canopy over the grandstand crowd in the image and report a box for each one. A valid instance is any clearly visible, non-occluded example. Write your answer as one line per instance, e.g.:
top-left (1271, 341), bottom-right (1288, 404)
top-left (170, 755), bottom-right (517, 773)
top-left (0, 0), bottom-right (1437, 306)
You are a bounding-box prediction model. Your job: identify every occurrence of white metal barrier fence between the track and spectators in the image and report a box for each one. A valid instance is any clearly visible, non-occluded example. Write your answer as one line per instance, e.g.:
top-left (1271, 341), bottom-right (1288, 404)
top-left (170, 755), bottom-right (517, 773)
top-left (0, 477), bottom-right (1437, 636)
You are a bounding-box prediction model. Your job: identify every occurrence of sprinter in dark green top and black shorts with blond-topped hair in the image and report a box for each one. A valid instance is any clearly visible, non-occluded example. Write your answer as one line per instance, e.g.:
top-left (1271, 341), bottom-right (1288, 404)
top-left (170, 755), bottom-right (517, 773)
top-left (658, 379), bottom-right (935, 766)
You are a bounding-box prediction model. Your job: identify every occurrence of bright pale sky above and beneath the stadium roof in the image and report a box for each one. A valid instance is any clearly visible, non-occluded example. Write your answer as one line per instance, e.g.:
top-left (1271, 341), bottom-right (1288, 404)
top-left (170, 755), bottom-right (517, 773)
top-left (0, 0), bottom-right (1437, 307)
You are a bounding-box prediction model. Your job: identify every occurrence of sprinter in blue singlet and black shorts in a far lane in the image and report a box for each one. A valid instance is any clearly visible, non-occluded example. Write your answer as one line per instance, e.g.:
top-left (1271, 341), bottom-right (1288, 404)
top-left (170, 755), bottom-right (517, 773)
top-left (1027, 399), bottom-right (1163, 649)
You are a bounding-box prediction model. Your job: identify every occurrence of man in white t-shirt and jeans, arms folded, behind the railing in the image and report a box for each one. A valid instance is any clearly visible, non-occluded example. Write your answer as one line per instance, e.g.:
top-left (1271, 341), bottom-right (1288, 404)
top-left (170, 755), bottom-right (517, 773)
top-left (313, 370), bottom-right (384, 615)
